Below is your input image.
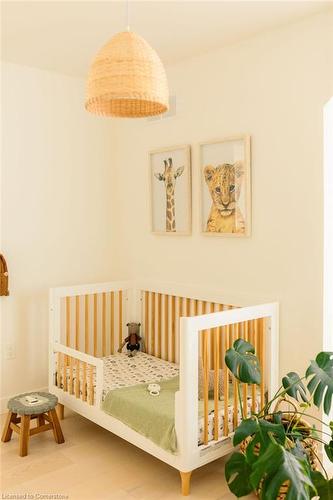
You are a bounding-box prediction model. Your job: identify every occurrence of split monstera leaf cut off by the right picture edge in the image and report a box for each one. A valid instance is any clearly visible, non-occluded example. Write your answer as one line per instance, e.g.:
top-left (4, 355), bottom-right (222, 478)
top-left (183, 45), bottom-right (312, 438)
top-left (306, 352), bottom-right (333, 415)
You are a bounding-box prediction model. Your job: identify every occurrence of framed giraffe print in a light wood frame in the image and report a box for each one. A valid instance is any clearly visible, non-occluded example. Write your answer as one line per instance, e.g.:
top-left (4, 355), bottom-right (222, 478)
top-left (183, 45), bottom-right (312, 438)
top-left (149, 145), bottom-right (192, 235)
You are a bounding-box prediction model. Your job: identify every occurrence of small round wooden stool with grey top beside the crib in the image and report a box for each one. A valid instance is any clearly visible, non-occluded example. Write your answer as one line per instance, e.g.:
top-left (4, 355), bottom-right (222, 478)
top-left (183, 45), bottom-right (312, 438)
top-left (1, 392), bottom-right (65, 457)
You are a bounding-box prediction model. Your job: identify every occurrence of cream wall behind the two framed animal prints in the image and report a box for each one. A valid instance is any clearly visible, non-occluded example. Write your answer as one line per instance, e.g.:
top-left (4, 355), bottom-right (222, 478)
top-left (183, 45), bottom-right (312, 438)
top-left (111, 13), bottom-right (333, 373)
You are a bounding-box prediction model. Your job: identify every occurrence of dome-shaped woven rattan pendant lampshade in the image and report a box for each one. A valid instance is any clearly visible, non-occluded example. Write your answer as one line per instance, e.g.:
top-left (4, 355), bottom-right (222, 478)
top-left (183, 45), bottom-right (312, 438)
top-left (85, 31), bottom-right (169, 118)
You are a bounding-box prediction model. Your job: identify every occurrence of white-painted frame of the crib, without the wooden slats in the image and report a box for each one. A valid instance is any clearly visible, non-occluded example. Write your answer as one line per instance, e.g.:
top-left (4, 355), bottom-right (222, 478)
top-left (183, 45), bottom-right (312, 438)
top-left (49, 281), bottom-right (279, 494)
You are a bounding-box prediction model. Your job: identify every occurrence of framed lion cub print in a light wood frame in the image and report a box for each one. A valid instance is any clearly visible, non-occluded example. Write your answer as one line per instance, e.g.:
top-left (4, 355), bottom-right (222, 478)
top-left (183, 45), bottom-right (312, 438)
top-left (200, 135), bottom-right (251, 237)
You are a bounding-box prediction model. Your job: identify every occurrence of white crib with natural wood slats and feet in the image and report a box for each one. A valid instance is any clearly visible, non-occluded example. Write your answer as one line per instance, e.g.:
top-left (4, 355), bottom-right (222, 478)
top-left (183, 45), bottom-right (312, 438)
top-left (49, 282), bottom-right (278, 495)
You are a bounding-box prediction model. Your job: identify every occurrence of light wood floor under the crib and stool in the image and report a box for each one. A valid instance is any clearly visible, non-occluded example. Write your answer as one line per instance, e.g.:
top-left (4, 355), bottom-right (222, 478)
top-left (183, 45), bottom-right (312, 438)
top-left (0, 410), bottom-right (255, 500)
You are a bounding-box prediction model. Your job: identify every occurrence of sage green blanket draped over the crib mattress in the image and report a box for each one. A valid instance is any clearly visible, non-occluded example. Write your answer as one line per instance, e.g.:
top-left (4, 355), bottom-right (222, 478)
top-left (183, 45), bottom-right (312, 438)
top-left (102, 377), bottom-right (179, 453)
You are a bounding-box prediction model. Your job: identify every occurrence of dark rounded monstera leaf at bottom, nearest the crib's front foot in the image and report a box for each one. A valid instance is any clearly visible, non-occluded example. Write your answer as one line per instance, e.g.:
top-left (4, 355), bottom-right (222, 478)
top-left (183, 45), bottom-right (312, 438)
top-left (225, 452), bottom-right (253, 498)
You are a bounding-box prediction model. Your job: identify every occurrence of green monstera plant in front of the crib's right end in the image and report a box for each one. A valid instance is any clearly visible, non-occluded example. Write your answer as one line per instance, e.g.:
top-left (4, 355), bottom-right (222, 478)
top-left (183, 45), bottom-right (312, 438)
top-left (225, 339), bottom-right (333, 500)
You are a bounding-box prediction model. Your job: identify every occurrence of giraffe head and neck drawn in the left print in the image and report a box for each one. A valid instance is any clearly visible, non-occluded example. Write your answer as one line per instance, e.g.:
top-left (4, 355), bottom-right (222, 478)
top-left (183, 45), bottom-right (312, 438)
top-left (154, 158), bottom-right (184, 232)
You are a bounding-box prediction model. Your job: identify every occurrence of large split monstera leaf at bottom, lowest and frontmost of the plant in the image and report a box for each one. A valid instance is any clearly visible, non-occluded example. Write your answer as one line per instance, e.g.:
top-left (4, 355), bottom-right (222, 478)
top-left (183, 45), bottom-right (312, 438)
top-left (250, 443), bottom-right (316, 500)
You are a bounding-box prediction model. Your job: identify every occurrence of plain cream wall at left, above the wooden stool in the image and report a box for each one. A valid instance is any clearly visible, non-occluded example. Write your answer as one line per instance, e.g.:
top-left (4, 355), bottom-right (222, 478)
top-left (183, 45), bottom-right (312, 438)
top-left (0, 64), bottom-right (115, 408)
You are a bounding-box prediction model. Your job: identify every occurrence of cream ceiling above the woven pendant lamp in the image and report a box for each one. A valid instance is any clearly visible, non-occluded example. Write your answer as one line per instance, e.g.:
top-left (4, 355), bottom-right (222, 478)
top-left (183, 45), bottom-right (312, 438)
top-left (1, 0), bottom-right (333, 76)
